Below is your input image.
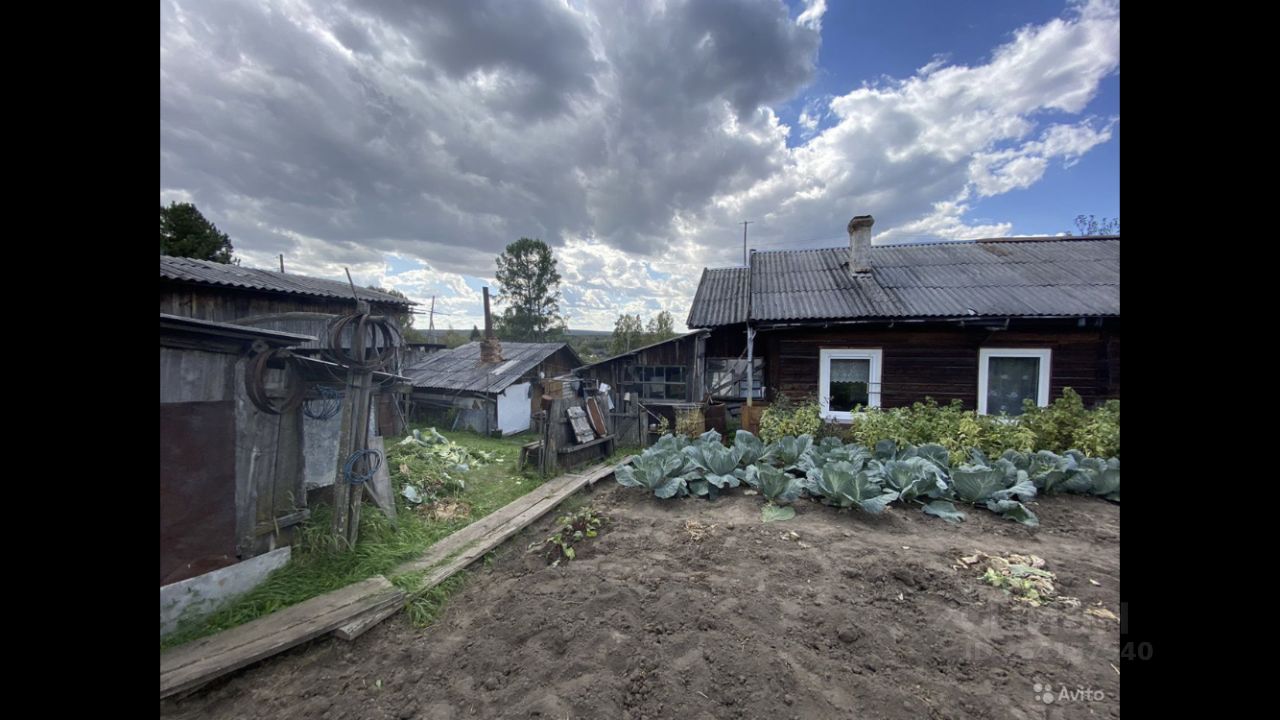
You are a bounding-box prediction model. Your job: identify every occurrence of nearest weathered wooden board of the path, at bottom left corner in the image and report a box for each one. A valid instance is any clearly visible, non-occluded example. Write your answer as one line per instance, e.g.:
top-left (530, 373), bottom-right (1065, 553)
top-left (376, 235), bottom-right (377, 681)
top-left (160, 575), bottom-right (404, 698)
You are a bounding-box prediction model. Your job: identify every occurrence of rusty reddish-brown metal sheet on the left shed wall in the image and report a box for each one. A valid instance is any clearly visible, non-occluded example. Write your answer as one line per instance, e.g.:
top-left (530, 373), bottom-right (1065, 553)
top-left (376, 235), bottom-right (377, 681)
top-left (160, 400), bottom-right (237, 585)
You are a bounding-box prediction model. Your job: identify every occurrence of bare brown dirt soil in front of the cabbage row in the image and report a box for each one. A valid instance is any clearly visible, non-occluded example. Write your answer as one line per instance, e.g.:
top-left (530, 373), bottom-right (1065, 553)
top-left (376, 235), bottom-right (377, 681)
top-left (161, 482), bottom-right (1120, 720)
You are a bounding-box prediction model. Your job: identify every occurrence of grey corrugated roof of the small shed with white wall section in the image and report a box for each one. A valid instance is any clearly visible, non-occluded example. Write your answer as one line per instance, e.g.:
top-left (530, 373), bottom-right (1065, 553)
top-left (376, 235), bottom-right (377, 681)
top-left (402, 341), bottom-right (577, 393)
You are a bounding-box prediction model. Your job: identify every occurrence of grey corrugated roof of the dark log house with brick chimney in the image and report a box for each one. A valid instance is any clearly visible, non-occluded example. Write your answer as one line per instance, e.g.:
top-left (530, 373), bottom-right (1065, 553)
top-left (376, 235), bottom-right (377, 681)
top-left (689, 237), bottom-right (1120, 328)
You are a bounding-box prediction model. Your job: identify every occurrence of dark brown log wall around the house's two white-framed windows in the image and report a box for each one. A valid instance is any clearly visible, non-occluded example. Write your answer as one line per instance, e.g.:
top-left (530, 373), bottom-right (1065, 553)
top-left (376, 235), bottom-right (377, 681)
top-left (708, 320), bottom-right (1120, 409)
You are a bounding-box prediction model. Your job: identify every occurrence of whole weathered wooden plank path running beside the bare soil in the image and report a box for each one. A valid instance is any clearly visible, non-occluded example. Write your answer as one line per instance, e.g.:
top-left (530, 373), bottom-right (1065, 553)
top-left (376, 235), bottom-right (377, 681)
top-left (160, 457), bottom-right (631, 700)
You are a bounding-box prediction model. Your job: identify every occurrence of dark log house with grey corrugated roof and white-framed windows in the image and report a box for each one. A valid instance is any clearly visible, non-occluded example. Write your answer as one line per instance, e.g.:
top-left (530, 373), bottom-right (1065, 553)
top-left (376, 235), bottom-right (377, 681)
top-left (687, 215), bottom-right (1120, 421)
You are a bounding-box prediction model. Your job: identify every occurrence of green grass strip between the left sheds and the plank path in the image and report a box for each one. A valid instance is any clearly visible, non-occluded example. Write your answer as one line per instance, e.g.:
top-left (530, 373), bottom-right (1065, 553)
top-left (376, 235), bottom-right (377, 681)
top-left (160, 425), bottom-right (541, 650)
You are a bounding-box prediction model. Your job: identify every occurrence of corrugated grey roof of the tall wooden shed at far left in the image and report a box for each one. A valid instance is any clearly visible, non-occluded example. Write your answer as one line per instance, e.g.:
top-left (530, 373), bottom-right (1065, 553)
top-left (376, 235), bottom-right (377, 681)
top-left (160, 255), bottom-right (416, 307)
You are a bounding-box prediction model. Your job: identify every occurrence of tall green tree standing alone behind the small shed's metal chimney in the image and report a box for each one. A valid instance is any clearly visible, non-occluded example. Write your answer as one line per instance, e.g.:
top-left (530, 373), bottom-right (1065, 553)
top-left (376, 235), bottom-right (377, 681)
top-left (495, 237), bottom-right (564, 342)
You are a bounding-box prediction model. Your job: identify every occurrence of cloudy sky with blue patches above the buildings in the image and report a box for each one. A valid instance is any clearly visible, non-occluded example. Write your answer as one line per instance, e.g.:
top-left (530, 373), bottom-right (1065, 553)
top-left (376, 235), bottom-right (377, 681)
top-left (160, 0), bottom-right (1120, 331)
